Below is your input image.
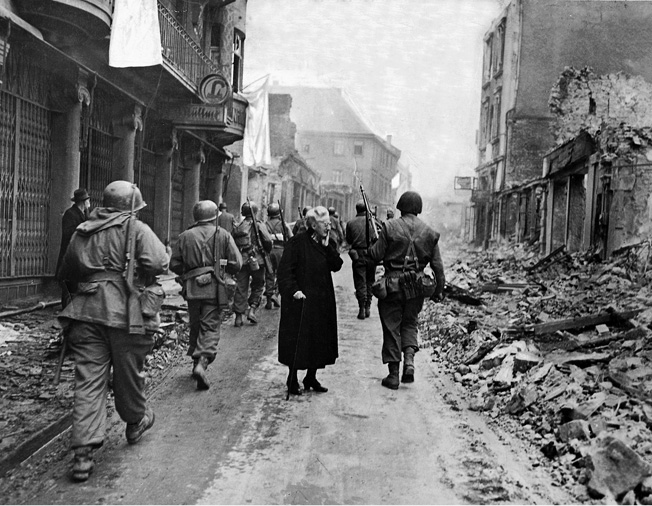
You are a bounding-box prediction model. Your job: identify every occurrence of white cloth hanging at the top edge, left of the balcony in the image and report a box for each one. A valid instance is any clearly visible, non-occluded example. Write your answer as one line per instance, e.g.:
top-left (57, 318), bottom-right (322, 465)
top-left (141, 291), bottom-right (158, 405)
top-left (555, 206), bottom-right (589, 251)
top-left (109, 0), bottom-right (163, 67)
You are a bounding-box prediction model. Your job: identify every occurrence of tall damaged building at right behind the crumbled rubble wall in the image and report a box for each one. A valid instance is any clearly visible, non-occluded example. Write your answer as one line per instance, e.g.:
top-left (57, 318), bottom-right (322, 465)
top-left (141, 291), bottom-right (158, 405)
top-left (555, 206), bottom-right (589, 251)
top-left (471, 0), bottom-right (652, 252)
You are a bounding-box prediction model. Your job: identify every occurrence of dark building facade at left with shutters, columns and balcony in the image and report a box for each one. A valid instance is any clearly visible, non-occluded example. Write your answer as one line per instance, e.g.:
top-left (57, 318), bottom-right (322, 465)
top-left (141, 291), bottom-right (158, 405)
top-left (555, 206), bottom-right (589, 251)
top-left (0, 0), bottom-right (247, 301)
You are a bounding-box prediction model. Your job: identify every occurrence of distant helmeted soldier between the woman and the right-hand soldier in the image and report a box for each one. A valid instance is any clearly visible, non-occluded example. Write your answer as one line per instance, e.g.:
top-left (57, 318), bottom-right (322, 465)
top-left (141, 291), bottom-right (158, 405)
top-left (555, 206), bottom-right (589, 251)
top-left (346, 199), bottom-right (376, 320)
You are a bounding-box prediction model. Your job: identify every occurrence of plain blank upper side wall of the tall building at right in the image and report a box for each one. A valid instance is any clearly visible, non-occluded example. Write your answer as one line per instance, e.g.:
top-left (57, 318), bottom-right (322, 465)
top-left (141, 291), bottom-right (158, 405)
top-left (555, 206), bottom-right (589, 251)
top-left (516, 0), bottom-right (652, 117)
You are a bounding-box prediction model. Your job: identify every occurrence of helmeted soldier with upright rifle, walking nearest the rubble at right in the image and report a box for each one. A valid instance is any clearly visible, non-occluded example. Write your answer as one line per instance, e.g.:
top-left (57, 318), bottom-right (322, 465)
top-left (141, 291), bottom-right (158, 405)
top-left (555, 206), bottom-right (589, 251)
top-left (369, 191), bottom-right (446, 390)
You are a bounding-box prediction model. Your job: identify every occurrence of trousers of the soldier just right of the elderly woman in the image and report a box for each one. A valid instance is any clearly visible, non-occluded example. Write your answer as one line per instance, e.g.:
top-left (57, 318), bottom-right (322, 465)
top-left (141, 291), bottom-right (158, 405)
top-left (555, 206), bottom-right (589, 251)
top-left (378, 292), bottom-right (423, 364)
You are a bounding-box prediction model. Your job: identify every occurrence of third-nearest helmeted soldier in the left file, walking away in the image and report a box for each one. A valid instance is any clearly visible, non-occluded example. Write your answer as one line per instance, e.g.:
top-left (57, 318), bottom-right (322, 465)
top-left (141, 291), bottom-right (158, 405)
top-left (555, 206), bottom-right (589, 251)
top-left (232, 202), bottom-right (272, 327)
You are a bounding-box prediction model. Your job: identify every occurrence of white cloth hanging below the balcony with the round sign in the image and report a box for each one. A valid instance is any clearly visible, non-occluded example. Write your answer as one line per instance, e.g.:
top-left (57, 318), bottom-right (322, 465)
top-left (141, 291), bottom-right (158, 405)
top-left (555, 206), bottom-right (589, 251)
top-left (240, 76), bottom-right (272, 167)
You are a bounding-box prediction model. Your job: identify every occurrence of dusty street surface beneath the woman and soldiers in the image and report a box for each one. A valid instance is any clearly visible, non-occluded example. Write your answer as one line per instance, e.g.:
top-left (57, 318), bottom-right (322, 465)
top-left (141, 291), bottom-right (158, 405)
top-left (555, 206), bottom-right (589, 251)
top-left (15, 256), bottom-right (572, 504)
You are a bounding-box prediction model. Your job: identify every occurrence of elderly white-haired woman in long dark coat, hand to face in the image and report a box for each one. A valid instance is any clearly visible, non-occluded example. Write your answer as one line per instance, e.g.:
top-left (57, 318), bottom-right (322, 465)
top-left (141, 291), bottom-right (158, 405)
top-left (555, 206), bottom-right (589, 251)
top-left (278, 206), bottom-right (343, 395)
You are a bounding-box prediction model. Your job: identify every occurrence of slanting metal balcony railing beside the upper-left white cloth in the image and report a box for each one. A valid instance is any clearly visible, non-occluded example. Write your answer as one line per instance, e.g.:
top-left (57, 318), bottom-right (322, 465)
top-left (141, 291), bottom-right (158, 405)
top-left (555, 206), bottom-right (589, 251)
top-left (158, 2), bottom-right (219, 91)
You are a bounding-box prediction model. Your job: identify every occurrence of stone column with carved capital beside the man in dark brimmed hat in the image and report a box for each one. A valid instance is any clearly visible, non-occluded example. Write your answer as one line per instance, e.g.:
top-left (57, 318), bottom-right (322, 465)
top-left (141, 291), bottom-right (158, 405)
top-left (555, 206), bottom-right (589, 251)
top-left (48, 73), bottom-right (91, 274)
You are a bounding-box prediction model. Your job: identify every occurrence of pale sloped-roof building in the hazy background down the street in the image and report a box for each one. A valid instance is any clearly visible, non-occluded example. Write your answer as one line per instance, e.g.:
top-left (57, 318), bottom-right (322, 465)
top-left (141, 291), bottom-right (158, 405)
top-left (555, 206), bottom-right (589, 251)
top-left (271, 86), bottom-right (401, 220)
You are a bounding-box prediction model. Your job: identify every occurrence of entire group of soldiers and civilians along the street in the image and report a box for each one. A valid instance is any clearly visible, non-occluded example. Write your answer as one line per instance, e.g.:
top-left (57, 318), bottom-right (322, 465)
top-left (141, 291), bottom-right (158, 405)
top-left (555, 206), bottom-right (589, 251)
top-left (57, 181), bottom-right (444, 481)
